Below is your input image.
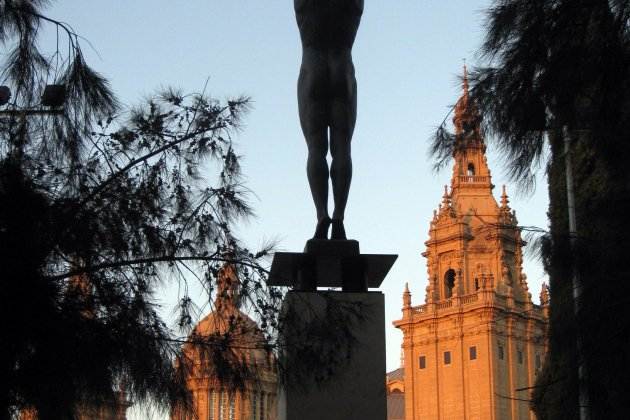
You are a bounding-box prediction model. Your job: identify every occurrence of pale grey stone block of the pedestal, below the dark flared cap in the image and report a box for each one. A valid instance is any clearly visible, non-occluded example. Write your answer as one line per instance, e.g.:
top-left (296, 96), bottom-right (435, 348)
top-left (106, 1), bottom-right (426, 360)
top-left (278, 291), bottom-right (387, 420)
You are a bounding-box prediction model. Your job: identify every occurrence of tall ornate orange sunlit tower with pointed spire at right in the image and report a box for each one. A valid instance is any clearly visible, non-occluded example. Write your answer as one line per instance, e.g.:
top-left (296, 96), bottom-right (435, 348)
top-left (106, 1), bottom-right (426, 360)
top-left (394, 68), bottom-right (548, 420)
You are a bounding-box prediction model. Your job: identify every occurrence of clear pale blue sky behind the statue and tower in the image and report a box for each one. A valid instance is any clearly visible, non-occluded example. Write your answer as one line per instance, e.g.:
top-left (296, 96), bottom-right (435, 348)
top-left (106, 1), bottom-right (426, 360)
top-left (41, 0), bottom-right (547, 416)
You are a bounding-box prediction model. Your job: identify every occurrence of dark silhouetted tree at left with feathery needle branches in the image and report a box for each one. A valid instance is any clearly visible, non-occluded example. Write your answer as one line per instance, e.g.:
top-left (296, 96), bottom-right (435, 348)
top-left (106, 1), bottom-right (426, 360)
top-left (0, 0), bottom-right (280, 419)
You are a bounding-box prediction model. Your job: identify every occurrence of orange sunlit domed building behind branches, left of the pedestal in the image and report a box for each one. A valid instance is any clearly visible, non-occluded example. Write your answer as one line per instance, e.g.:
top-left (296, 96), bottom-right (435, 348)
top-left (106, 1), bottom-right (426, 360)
top-left (171, 264), bottom-right (278, 420)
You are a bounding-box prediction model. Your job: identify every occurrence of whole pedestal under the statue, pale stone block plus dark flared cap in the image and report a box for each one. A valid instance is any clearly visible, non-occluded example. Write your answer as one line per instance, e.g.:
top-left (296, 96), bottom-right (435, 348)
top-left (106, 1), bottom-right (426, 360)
top-left (268, 240), bottom-right (397, 420)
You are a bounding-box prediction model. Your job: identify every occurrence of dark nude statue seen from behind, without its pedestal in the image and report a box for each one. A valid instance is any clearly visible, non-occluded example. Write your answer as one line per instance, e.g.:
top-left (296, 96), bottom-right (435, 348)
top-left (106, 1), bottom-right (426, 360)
top-left (294, 0), bottom-right (364, 239)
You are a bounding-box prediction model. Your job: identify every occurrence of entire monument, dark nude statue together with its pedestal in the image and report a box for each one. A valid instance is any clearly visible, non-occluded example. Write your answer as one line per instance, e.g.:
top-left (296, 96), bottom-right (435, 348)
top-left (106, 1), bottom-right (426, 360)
top-left (268, 0), bottom-right (397, 420)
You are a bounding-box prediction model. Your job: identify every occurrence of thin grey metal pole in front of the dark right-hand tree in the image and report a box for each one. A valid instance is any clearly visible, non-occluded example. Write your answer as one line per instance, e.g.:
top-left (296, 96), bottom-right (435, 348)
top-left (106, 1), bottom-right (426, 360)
top-left (562, 125), bottom-right (590, 420)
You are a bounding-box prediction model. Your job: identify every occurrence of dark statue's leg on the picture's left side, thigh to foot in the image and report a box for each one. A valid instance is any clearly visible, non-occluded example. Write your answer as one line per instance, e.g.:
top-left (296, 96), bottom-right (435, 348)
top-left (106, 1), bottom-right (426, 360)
top-left (298, 63), bottom-right (330, 239)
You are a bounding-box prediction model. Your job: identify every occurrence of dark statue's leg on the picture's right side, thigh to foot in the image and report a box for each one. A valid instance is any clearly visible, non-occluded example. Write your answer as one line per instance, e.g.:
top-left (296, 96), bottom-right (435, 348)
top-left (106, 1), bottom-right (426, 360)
top-left (330, 59), bottom-right (357, 239)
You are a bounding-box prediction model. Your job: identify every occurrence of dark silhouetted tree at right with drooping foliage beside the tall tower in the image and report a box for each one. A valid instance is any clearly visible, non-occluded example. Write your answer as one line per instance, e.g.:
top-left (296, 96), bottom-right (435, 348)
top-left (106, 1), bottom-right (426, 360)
top-left (433, 0), bottom-right (630, 419)
